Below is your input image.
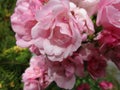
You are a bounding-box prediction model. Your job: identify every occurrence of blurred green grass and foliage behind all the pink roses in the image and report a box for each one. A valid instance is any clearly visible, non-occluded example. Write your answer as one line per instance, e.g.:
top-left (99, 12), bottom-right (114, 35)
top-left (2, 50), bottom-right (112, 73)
top-left (0, 0), bottom-right (120, 90)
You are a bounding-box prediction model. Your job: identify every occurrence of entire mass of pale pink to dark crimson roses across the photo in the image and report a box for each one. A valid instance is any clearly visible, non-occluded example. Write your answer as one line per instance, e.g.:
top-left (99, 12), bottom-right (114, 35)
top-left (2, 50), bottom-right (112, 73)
top-left (11, 0), bottom-right (120, 90)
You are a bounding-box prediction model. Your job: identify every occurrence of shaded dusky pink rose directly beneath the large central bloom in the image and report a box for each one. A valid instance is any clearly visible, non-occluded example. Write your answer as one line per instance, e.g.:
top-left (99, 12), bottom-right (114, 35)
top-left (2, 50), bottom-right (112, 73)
top-left (47, 56), bottom-right (84, 89)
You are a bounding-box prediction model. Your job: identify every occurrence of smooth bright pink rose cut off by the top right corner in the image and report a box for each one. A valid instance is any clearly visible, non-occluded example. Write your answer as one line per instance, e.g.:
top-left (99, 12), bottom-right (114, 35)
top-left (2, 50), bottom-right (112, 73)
top-left (97, 0), bottom-right (120, 30)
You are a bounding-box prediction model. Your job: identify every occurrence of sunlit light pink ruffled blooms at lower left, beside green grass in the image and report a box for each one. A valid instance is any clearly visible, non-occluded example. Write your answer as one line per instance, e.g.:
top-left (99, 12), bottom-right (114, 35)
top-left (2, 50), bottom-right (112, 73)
top-left (22, 55), bottom-right (52, 90)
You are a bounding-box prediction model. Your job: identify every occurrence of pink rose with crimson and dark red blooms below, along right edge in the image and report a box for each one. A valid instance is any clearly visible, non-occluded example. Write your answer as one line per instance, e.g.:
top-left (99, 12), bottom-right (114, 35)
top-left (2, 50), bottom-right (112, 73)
top-left (97, 0), bottom-right (120, 69)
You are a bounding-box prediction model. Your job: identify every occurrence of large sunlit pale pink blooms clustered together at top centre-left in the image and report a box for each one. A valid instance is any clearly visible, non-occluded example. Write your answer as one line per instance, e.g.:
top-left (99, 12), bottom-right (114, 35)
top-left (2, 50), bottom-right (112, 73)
top-left (11, 0), bottom-right (94, 61)
